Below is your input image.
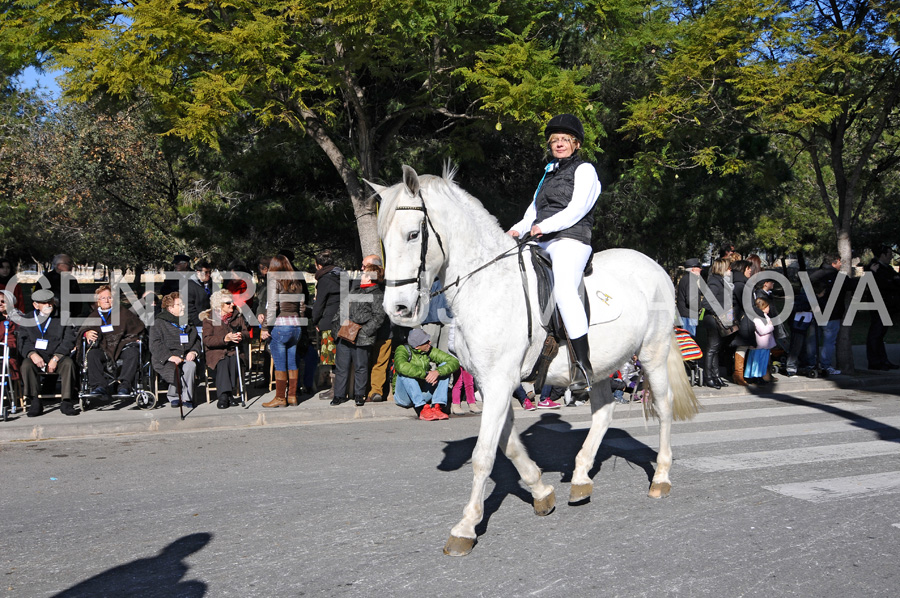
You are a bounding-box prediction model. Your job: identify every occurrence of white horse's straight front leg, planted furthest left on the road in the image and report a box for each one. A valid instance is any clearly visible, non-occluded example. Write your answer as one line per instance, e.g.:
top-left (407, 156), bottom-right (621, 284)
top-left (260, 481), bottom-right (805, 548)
top-left (444, 386), bottom-right (512, 556)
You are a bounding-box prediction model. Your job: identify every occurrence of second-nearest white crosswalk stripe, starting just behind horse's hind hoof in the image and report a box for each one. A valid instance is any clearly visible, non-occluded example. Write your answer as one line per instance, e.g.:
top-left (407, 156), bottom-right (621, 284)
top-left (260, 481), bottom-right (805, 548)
top-left (678, 440), bottom-right (900, 473)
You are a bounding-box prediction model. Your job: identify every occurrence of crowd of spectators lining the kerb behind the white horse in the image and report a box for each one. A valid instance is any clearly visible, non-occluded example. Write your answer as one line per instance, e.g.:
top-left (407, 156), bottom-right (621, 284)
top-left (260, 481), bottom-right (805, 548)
top-left (0, 243), bottom-right (900, 421)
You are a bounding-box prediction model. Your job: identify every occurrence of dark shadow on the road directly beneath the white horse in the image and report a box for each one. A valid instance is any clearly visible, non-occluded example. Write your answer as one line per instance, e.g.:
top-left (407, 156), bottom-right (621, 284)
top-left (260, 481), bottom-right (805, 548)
top-left (437, 412), bottom-right (656, 536)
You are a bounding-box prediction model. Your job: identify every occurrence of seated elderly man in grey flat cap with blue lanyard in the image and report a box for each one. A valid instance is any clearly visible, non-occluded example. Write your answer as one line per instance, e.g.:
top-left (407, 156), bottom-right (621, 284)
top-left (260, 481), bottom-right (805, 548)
top-left (19, 289), bottom-right (78, 417)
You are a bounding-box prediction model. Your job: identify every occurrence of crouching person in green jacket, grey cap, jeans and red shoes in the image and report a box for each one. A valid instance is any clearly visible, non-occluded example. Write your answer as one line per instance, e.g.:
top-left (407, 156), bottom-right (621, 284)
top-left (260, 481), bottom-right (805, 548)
top-left (393, 328), bottom-right (459, 421)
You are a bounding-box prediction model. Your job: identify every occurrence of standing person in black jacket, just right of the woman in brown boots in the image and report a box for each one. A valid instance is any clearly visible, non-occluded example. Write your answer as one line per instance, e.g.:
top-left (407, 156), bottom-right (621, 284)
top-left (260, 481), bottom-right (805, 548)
top-left (312, 250), bottom-right (349, 401)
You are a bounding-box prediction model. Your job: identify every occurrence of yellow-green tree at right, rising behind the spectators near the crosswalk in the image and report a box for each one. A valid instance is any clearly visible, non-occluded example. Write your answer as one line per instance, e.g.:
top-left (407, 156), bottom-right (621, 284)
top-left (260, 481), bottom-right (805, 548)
top-left (627, 0), bottom-right (900, 370)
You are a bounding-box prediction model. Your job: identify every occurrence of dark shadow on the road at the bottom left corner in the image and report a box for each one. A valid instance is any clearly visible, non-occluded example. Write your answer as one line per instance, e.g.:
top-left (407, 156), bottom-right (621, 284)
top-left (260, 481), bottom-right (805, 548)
top-left (54, 533), bottom-right (212, 598)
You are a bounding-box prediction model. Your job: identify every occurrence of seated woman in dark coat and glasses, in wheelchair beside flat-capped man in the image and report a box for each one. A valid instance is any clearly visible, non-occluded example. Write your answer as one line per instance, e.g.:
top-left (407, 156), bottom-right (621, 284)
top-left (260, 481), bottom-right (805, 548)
top-left (78, 285), bottom-right (146, 399)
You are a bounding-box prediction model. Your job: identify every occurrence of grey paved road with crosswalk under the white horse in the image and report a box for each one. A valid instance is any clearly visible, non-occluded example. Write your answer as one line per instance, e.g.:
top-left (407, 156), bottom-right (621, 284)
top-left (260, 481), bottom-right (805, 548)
top-left (0, 389), bottom-right (900, 598)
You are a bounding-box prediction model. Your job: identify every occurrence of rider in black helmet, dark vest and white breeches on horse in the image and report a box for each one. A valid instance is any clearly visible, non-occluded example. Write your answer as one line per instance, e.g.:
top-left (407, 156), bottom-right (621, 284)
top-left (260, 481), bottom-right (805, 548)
top-left (508, 114), bottom-right (600, 391)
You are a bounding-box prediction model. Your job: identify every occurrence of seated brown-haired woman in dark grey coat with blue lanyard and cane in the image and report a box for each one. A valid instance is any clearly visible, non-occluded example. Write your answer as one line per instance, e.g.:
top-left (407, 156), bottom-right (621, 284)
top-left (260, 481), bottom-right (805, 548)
top-left (150, 292), bottom-right (200, 409)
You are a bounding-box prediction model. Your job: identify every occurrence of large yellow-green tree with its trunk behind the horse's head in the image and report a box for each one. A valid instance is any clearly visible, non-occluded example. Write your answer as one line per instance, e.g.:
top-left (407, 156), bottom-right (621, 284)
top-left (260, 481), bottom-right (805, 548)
top-left (0, 0), bottom-right (596, 253)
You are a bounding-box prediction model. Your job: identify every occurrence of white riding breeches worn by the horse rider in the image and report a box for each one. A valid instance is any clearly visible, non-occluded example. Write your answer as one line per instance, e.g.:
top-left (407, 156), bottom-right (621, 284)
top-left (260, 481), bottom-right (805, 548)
top-left (538, 239), bottom-right (594, 338)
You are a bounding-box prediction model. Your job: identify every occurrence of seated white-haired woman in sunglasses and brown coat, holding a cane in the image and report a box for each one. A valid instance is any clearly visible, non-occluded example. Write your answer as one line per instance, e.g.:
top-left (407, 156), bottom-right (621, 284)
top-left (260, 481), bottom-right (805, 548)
top-left (200, 289), bottom-right (250, 409)
